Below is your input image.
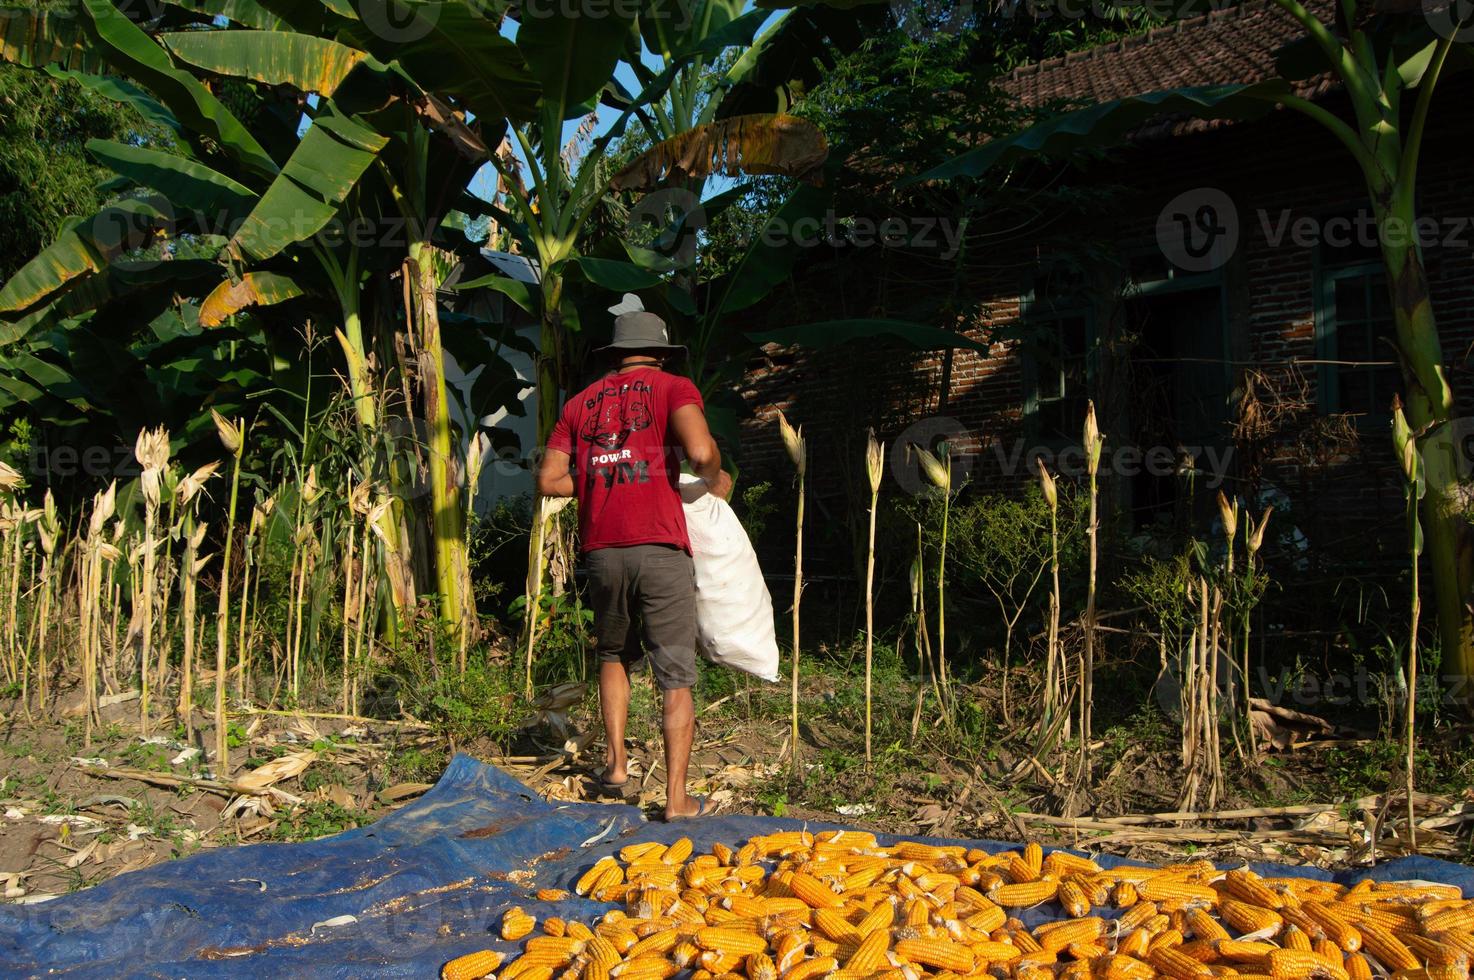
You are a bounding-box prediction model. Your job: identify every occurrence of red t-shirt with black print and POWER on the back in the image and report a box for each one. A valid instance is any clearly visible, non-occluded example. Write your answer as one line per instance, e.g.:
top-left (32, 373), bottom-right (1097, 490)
top-left (548, 367), bottom-right (705, 551)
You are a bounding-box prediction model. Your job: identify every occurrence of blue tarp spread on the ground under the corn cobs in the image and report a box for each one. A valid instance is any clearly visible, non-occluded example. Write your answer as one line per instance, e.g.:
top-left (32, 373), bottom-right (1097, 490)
top-left (0, 756), bottom-right (1474, 979)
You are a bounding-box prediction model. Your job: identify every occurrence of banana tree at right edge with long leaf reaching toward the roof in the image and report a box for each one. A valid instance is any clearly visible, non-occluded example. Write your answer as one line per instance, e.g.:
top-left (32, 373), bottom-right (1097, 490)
top-left (904, 0), bottom-right (1474, 676)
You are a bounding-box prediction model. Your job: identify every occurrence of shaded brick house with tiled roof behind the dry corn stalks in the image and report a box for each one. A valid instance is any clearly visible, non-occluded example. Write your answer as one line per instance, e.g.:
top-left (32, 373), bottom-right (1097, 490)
top-left (744, 0), bottom-right (1474, 580)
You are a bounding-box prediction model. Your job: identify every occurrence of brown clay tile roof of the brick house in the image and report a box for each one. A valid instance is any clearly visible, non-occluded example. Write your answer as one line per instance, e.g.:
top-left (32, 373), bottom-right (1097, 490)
top-left (999, 0), bottom-right (1334, 136)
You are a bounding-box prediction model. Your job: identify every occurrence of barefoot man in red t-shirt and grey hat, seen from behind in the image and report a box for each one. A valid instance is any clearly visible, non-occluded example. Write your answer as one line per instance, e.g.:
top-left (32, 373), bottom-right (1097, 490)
top-left (538, 296), bottom-right (731, 819)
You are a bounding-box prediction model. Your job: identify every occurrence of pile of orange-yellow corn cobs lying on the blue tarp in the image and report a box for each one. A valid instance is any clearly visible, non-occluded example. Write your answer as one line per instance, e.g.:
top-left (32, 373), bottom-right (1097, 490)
top-left (442, 831), bottom-right (1474, 980)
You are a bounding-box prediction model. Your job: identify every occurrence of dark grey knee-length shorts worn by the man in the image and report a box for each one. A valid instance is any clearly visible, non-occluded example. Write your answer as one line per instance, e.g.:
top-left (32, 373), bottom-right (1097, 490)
top-left (584, 544), bottom-right (696, 691)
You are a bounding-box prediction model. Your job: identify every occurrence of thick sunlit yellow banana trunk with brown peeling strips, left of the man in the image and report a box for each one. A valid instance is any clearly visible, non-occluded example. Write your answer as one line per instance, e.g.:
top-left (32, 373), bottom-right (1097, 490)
top-left (408, 242), bottom-right (473, 635)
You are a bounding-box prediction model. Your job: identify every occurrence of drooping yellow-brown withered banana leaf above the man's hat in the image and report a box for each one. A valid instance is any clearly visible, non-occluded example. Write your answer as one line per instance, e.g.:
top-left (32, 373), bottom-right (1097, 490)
top-left (610, 113), bottom-right (828, 190)
